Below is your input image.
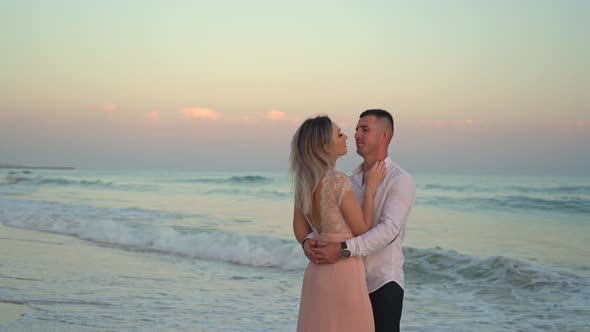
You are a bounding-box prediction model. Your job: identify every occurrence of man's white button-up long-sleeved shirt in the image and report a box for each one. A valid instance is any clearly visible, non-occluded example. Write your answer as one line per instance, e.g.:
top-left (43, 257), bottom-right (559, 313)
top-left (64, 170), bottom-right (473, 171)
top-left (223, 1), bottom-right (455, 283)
top-left (346, 157), bottom-right (416, 292)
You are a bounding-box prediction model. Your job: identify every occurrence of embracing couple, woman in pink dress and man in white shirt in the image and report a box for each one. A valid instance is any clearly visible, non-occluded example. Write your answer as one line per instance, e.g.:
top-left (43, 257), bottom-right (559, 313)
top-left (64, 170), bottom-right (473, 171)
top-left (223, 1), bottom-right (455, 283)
top-left (290, 109), bottom-right (416, 332)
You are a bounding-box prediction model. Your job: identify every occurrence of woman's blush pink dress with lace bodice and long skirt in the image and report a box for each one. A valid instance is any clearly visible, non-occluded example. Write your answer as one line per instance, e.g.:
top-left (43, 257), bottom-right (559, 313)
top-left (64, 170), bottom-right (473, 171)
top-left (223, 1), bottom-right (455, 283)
top-left (297, 171), bottom-right (375, 332)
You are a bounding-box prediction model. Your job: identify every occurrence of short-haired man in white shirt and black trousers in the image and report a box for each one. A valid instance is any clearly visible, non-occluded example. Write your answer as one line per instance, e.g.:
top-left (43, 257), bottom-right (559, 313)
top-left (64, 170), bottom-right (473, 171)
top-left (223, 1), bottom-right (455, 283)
top-left (303, 109), bottom-right (416, 332)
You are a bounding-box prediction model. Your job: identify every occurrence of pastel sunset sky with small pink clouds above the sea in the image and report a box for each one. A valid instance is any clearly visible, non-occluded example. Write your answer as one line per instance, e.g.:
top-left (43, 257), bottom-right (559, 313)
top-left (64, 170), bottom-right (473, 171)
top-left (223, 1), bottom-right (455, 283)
top-left (0, 0), bottom-right (590, 175)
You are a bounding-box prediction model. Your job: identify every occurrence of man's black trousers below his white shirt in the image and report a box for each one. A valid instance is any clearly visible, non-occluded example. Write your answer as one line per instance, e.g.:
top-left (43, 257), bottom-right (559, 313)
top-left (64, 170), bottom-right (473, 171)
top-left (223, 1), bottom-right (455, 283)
top-left (369, 281), bottom-right (404, 332)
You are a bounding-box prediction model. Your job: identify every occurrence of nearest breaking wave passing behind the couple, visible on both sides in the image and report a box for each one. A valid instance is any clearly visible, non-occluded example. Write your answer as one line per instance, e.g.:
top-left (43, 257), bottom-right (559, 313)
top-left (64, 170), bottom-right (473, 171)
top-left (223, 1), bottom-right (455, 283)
top-left (0, 199), bottom-right (590, 296)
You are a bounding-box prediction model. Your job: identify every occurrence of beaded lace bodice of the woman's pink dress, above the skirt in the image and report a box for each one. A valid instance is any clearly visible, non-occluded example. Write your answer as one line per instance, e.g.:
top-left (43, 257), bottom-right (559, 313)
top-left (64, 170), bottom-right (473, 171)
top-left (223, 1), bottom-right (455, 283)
top-left (310, 171), bottom-right (352, 237)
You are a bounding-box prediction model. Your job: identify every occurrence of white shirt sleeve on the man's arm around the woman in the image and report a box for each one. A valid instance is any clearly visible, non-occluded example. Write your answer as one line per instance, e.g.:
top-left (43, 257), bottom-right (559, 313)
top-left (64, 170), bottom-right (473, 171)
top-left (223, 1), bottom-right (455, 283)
top-left (346, 174), bottom-right (416, 256)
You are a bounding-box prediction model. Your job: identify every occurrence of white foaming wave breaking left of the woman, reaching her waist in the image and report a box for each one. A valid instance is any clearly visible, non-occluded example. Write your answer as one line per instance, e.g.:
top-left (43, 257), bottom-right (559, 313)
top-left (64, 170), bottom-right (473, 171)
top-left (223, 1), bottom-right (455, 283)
top-left (0, 200), bottom-right (305, 270)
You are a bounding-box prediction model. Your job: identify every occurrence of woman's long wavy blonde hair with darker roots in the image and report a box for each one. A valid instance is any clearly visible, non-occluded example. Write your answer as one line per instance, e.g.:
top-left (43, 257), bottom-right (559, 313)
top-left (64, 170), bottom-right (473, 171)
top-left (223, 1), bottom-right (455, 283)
top-left (290, 115), bottom-right (334, 215)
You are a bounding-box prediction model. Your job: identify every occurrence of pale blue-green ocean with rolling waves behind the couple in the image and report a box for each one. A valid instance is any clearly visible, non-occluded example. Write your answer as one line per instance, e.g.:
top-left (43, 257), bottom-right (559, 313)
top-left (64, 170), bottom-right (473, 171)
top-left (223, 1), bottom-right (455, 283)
top-left (0, 169), bottom-right (590, 332)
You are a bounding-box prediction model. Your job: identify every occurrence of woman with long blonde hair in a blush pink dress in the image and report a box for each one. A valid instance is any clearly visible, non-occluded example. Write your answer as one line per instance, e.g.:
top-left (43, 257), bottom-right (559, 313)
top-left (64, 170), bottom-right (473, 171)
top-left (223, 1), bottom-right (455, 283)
top-left (291, 116), bottom-right (385, 332)
